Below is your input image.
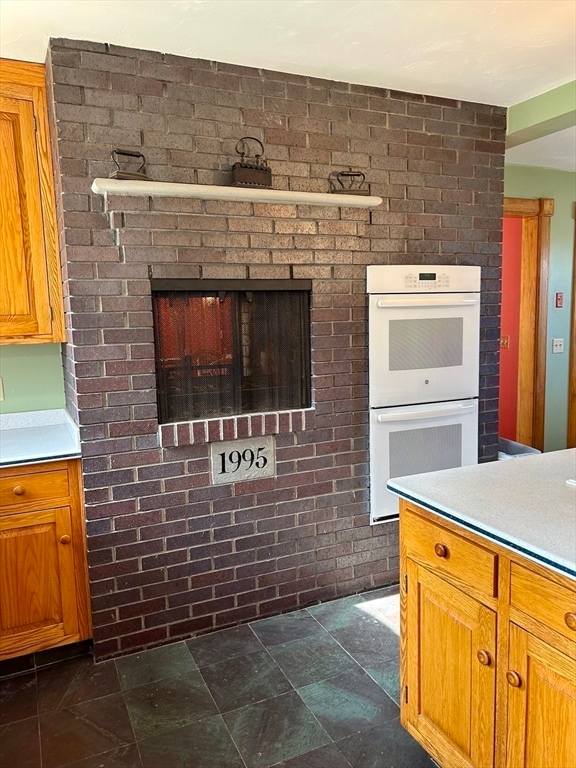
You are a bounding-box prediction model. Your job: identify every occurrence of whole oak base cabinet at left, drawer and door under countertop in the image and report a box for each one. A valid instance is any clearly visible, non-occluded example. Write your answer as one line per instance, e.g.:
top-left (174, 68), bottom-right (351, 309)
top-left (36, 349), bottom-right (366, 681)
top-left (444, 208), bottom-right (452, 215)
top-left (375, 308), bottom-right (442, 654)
top-left (0, 459), bottom-right (91, 659)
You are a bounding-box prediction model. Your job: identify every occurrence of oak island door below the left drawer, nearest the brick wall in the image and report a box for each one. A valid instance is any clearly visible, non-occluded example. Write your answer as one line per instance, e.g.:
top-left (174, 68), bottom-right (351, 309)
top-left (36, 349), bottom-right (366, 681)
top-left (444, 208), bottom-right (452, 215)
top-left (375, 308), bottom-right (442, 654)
top-left (402, 559), bottom-right (496, 768)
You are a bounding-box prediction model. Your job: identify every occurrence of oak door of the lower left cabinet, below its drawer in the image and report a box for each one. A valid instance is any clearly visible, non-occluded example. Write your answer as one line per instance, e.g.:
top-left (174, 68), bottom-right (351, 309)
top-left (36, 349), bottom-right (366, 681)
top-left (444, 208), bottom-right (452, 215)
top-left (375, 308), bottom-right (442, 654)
top-left (0, 506), bottom-right (79, 658)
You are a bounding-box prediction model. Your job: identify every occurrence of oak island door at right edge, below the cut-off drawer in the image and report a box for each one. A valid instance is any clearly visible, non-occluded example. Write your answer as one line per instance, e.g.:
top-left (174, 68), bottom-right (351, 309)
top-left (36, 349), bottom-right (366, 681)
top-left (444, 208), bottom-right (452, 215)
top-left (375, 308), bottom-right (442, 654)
top-left (506, 624), bottom-right (576, 768)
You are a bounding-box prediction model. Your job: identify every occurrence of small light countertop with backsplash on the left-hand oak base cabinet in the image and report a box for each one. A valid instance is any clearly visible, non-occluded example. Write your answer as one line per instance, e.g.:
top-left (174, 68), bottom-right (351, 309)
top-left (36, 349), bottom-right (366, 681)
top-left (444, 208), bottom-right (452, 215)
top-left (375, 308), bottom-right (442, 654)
top-left (0, 408), bottom-right (80, 467)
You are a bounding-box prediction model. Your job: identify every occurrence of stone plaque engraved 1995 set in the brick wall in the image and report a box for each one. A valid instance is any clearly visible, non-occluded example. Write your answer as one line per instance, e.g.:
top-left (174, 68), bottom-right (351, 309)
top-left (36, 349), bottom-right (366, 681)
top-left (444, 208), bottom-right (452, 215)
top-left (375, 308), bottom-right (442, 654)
top-left (210, 435), bottom-right (276, 485)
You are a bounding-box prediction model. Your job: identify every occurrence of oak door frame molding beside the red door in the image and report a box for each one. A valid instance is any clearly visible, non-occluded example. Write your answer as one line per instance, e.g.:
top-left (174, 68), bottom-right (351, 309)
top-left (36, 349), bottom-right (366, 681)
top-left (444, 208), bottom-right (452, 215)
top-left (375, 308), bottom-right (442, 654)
top-left (503, 197), bottom-right (554, 451)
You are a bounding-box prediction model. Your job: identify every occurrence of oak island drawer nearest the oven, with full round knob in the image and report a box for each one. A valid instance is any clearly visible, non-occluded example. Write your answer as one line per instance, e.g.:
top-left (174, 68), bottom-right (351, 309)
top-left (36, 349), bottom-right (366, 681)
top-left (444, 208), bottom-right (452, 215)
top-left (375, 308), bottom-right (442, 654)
top-left (402, 511), bottom-right (498, 597)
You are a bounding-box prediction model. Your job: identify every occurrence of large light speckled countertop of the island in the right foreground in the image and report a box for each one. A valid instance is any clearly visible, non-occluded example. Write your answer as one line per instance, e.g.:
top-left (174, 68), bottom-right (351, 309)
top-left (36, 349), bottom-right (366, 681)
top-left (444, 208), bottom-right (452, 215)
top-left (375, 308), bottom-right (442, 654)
top-left (388, 448), bottom-right (576, 577)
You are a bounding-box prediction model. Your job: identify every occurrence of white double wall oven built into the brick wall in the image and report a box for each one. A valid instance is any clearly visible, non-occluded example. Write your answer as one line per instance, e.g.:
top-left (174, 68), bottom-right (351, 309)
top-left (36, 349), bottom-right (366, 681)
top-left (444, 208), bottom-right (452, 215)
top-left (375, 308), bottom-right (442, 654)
top-left (367, 265), bottom-right (480, 523)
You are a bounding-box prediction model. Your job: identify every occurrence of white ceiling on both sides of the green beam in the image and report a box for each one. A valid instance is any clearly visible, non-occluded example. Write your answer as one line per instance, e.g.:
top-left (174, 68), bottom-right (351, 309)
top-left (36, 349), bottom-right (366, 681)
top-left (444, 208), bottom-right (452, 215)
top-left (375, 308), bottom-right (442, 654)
top-left (0, 0), bottom-right (576, 170)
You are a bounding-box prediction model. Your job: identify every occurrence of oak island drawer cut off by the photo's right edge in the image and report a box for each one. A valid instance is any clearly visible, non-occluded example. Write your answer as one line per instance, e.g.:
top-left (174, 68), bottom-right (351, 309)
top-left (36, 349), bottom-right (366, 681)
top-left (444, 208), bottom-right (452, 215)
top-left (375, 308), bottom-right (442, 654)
top-left (510, 563), bottom-right (576, 641)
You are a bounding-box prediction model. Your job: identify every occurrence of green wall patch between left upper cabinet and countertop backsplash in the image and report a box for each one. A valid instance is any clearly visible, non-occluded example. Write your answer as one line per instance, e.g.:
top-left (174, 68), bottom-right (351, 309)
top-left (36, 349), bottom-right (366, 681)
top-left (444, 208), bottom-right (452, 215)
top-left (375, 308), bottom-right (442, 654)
top-left (0, 344), bottom-right (65, 413)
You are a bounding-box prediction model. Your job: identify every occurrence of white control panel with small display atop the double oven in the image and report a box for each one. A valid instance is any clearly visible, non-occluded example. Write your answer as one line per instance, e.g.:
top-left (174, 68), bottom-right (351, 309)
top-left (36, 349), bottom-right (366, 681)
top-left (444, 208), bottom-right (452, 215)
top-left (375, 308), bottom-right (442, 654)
top-left (366, 264), bottom-right (480, 293)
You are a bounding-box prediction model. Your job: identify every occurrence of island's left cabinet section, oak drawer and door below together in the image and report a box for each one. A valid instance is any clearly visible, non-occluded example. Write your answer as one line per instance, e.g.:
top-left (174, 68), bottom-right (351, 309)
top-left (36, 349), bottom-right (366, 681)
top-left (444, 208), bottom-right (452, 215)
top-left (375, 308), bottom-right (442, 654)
top-left (401, 511), bottom-right (496, 768)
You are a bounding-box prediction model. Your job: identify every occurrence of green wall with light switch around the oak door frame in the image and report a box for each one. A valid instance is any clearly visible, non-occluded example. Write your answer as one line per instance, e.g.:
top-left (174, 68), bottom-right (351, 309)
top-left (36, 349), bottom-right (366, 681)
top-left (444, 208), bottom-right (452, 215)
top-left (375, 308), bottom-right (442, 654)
top-left (504, 165), bottom-right (576, 451)
